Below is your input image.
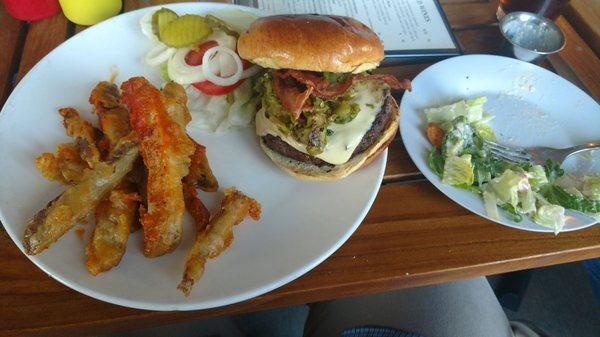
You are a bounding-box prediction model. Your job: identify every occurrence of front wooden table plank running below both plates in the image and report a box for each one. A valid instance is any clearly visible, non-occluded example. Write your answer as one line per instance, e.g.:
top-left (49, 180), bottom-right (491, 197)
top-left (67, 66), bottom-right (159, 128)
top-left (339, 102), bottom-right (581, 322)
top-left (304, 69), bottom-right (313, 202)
top-left (0, 182), bottom-right (600, 336)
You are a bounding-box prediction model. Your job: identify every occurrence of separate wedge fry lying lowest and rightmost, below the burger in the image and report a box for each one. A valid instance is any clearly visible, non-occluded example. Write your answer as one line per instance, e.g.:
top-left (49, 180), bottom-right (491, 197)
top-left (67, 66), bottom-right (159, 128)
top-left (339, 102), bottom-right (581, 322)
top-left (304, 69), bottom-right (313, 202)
top-left (177, 187), bottom-right (260, 296)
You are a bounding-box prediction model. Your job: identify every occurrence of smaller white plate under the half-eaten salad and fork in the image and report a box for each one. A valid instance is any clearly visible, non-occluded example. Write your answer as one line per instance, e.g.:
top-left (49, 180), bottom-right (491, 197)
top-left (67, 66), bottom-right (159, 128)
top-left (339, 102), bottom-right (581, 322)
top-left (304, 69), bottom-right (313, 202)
top-left (400, 55), bottom-right (600, 232)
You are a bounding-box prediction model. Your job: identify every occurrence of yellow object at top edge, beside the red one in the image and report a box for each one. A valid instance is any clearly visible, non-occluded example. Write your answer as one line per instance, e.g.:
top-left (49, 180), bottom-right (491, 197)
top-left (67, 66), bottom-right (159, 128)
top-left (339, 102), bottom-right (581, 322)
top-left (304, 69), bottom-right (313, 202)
top-left (59, 0), bottom-right (123, 26)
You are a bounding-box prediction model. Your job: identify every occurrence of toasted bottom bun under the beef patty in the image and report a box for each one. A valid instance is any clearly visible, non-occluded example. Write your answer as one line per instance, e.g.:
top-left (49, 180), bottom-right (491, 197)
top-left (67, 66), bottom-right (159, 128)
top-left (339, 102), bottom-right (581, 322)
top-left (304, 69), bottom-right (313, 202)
top-left (260, 99), bottom-right (400, 181)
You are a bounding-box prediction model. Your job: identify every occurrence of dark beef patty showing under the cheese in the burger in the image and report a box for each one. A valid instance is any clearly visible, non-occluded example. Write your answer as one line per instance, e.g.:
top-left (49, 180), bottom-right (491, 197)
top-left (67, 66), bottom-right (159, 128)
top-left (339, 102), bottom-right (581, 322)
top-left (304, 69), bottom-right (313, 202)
top-left (262, 91), bottom-right (393, 167)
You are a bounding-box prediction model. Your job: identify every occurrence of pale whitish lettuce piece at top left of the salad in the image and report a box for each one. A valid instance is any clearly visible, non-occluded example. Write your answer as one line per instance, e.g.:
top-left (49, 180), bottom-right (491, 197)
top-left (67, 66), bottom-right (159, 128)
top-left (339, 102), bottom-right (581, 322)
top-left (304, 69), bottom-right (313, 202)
top-left (424, 96), bottom-right (487, 125)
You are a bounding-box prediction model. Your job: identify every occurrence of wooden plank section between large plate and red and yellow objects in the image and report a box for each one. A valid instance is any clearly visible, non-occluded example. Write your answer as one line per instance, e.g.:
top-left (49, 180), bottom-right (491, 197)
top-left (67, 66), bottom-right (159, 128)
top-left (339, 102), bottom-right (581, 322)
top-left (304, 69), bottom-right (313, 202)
top-left (17, 13), bottom-right (68, 82)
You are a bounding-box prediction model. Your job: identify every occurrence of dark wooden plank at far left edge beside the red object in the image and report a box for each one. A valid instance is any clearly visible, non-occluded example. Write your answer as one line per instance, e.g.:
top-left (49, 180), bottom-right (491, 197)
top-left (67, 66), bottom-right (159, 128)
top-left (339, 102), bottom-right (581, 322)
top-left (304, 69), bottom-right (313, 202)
top-left (0, 6), bottom-right (27, 107)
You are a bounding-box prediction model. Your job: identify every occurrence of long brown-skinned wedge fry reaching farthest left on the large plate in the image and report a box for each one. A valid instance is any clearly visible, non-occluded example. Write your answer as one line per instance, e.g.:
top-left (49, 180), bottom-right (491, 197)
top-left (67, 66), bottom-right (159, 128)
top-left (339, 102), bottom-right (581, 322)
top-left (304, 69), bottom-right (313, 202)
top-left (23, 135), bottom-right (139, 255)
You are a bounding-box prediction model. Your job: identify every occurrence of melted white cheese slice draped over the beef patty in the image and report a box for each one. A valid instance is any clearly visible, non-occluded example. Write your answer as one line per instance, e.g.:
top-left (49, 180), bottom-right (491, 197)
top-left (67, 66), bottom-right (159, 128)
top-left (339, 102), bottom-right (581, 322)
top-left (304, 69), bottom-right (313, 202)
top-left (256, 81), bottom-right (385, 165)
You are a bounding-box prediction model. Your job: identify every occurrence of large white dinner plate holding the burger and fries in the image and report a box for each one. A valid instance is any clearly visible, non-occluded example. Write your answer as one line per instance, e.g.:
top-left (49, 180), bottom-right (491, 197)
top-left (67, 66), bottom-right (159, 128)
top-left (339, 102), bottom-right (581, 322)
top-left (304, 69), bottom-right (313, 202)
top-left (0, 3), bottom-right (387, 310)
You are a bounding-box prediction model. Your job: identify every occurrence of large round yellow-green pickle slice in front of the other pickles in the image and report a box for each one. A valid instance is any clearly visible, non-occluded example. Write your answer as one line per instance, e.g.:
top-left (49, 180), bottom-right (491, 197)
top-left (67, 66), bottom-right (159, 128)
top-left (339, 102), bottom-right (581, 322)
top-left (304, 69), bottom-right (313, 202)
top-left (158, 14), bottom-right (212, 48)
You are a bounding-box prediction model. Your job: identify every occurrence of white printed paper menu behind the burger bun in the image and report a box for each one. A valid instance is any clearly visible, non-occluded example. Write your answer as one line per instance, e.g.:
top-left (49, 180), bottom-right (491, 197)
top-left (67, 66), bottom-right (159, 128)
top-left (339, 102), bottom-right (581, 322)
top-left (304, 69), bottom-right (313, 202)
top-left (250, 0), bottom-right (458, 54)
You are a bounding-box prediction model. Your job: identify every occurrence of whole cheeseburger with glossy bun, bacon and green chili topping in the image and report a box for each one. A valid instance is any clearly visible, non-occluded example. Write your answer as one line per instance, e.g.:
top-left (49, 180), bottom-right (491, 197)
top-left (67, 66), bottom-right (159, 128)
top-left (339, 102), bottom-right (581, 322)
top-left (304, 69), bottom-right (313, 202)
top-left (237, 15), bottom-right (410, 180)
